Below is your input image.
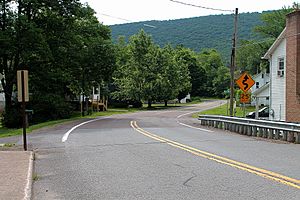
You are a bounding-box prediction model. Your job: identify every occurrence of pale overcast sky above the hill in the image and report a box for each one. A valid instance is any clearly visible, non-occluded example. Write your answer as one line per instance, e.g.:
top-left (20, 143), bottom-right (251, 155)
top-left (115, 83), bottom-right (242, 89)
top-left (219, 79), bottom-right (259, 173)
top-left (81, 0), bottom-right (299, 25)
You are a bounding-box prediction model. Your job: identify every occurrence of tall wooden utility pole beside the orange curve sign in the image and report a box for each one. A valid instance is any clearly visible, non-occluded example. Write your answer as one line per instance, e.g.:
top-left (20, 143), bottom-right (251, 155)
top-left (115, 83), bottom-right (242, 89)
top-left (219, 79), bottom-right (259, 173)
top-left (229, 8), bottom-right (238, 117)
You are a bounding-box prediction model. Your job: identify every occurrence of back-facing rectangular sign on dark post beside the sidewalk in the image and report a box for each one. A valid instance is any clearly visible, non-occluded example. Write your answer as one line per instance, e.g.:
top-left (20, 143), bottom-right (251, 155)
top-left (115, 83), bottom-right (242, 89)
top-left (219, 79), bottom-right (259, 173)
top-left (17, 70), bottom-right (29, 151)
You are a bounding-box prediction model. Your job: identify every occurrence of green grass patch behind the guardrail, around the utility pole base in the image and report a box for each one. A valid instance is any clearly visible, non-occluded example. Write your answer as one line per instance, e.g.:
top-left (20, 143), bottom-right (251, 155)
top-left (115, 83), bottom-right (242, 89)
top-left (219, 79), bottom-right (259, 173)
top-left (193, 104), bottom-right (255, 118)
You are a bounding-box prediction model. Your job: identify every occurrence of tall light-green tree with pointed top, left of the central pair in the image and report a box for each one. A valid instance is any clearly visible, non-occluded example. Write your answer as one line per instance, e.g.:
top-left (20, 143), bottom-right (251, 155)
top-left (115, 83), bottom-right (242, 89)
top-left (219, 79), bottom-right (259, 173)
top-left (114, 30), bottom-right (158, 107)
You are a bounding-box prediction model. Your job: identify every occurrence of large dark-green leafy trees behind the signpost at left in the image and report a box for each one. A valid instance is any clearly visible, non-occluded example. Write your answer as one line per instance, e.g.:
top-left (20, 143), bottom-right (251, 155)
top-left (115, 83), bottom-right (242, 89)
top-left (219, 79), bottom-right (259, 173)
top-left (0, 0), bottom-right (114, 126)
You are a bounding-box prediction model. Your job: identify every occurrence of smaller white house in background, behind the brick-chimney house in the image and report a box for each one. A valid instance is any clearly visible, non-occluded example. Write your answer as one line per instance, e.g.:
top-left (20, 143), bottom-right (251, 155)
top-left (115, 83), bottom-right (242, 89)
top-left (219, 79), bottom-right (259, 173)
top-left (251, 70), bottom-right (270, 106)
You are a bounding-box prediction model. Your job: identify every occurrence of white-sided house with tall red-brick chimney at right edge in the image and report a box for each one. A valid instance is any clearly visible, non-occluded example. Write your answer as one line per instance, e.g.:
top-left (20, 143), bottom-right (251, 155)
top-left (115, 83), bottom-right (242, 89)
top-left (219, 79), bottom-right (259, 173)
top-left (263, 10), bottom-right (300, 122)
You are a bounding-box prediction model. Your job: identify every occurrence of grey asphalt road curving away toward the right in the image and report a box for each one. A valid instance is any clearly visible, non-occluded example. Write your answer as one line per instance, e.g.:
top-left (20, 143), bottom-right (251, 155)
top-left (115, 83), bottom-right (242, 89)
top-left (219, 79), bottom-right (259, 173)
top-left (28, 101), bottom-right (300, 200)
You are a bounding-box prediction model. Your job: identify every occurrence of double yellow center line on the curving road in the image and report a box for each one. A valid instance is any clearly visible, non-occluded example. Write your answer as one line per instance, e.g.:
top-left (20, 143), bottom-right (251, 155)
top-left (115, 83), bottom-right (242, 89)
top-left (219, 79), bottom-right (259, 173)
top-left (130, 121), bottom-right (300, 189)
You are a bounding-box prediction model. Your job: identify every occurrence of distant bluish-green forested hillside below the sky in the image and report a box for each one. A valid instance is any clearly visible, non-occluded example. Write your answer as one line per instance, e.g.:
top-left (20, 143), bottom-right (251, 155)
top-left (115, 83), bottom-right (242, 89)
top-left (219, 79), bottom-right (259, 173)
top-left (111, 13), bottom-right (261, 62)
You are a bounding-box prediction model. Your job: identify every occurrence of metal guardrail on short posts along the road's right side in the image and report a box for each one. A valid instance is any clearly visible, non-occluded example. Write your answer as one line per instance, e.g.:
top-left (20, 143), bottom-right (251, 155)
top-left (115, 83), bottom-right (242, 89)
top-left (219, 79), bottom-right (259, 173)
top-left (199, 115), bottom-right (300, 144)
